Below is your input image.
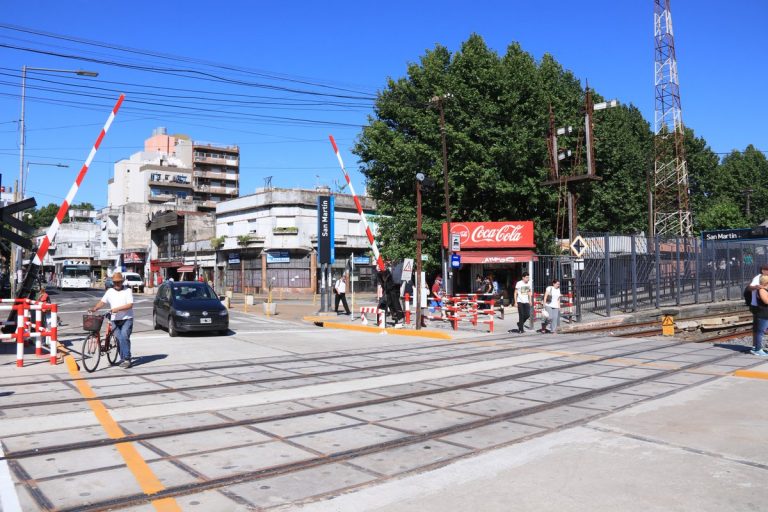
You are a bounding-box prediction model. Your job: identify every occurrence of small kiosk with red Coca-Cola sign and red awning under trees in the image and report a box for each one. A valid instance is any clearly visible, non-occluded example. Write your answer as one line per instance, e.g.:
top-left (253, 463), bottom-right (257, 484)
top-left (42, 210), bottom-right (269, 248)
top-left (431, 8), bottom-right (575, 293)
top-left (443, 221), bottom-right (537, 298)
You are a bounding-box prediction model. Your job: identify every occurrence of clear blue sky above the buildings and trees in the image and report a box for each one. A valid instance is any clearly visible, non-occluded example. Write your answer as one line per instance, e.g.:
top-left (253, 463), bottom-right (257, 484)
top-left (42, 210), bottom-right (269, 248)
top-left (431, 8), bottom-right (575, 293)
top-left (0, 0), bottom-right (768, 210)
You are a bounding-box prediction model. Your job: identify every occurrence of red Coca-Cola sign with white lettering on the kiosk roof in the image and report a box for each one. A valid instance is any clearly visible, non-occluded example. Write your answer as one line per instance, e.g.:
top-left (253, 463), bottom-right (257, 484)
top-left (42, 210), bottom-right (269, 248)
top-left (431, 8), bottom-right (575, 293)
top-left (443, 220), bottom-right (534, 250)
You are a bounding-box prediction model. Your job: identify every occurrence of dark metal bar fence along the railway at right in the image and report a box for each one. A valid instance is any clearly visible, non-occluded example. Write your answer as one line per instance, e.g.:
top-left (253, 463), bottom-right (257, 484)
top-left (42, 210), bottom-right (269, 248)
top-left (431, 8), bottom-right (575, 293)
top-left (533, 234), bottom-right (768, 316)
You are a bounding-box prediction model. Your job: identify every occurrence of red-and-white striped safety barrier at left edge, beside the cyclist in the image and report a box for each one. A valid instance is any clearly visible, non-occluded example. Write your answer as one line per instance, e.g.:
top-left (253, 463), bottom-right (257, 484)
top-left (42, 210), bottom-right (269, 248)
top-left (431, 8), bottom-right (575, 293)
top-left (0, 299), bottom-right (59, 367)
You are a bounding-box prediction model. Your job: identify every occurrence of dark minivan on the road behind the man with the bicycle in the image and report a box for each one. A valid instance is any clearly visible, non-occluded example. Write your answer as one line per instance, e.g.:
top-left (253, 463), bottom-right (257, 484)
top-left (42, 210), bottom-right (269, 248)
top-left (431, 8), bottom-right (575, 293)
top-left (152, 281), bottom-right (229, 337)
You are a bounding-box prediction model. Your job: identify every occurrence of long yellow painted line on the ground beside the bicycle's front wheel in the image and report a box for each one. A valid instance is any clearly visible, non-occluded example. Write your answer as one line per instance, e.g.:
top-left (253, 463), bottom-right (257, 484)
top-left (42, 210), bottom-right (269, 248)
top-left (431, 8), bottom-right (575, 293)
top-left (65, 354), bottom-right (181, 512)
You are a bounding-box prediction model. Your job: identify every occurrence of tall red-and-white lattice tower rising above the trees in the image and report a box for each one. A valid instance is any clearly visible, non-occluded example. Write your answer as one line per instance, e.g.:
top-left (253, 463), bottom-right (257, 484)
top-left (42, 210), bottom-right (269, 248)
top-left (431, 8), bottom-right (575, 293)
top-left (652, 0), bottom-right (692, 236)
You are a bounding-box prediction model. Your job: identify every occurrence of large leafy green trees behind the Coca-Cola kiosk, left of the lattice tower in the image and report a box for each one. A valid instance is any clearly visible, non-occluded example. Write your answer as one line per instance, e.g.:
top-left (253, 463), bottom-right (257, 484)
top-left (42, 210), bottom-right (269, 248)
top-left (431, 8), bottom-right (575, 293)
top-left (353, 35), bottom-right (652, 264)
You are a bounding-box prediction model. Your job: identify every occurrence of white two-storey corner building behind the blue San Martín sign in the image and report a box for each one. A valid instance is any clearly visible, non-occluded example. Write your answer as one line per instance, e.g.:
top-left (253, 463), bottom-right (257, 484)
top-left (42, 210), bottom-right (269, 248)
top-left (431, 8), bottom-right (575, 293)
top-left (216, 187), bottom-right (376, 292)
